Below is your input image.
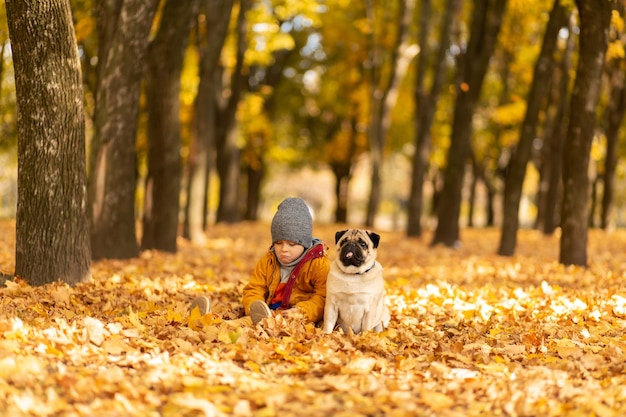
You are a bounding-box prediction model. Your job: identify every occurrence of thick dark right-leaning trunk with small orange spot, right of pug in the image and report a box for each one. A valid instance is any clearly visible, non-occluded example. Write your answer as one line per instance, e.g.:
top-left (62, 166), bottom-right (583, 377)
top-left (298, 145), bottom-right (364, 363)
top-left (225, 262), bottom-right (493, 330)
top-left (432, 0), bottom-right (506, 247)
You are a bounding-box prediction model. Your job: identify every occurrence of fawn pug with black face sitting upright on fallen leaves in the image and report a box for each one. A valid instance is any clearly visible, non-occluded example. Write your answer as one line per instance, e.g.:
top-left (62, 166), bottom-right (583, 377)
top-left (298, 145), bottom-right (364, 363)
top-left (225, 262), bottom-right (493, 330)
top-left (323, 229), bottom-right (390, 334)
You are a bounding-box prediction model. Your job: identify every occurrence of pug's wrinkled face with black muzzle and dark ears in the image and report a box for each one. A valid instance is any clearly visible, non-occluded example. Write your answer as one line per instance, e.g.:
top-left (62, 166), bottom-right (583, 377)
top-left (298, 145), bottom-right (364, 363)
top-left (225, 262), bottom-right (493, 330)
top-left (335, 229), bottom-right (380, 274)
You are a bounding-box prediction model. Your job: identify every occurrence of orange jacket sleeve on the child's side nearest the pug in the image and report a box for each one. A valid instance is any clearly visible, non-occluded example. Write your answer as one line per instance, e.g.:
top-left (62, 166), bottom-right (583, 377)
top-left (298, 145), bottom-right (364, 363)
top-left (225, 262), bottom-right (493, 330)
top-left (295, 256), bottom-right (330, 323)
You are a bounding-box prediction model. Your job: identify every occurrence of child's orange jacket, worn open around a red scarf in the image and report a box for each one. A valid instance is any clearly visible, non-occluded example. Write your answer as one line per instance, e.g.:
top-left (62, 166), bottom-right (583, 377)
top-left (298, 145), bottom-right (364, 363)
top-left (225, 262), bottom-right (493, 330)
top-left (242, 243), bottom-right (330, 323)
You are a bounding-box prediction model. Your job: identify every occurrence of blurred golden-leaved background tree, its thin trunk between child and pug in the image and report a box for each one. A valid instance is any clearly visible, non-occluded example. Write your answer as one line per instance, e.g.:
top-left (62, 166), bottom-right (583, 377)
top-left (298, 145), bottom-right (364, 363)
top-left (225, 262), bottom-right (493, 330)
top-left (258, 2), bottom-right (370, 223)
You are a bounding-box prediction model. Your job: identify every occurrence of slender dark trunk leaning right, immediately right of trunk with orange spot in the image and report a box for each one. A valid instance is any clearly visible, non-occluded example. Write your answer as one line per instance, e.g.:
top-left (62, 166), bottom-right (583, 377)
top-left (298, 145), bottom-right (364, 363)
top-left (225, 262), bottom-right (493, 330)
top-left (498, 0), bottom-right (567, 256)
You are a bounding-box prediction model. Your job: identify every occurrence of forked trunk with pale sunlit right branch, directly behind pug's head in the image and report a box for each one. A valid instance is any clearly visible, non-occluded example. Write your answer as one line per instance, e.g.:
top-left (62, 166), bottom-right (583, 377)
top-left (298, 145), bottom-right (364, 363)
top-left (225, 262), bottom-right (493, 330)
top-left (365, 0), bottom-right (417, 227)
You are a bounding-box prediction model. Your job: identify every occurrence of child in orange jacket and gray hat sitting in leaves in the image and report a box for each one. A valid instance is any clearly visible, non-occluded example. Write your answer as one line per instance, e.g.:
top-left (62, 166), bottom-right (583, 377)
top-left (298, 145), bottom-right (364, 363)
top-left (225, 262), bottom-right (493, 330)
top-left (190, 198), bottom-right (330, 325)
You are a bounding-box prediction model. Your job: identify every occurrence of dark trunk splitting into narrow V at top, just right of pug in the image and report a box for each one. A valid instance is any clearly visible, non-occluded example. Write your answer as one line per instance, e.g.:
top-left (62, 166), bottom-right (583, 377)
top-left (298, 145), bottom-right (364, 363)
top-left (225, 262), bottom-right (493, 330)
top-left (407, 0), bottom-right (460, 237)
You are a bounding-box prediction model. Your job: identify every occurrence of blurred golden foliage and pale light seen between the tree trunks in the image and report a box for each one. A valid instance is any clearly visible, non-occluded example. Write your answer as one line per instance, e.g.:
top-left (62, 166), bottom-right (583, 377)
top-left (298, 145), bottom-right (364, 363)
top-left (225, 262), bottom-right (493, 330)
top-left (0, 0), bottom-right (626, 234)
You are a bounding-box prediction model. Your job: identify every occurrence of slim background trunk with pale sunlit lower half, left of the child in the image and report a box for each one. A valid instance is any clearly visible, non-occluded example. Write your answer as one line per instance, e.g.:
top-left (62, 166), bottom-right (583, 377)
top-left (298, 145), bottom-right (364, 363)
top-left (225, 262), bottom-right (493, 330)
top-left (183, 0), bottom-right (234, 242)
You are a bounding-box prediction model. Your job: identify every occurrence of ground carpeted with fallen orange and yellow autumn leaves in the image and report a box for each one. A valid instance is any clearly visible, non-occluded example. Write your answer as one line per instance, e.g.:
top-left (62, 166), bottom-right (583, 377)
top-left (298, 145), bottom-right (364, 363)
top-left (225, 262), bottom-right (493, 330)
top-left (0, 222), bottom-right (626, 417)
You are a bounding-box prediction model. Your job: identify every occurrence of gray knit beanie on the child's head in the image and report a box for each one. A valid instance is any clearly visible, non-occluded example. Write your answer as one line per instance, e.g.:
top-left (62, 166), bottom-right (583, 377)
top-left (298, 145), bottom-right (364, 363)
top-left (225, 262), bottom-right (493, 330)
top-left (271, 197), bottom-right (313, 248)
